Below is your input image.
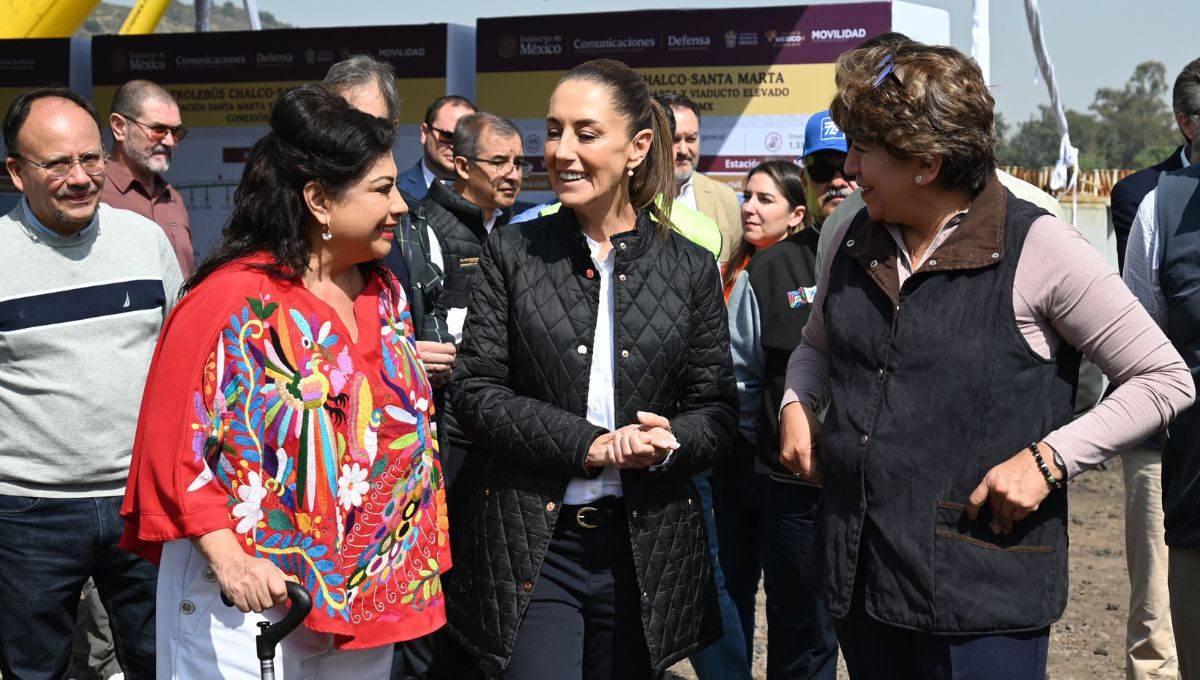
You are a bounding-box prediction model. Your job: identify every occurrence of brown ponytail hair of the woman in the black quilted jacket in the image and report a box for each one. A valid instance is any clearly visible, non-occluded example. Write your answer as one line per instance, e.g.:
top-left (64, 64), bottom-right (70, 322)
top-left (558, 59), bottom-right (674, 235)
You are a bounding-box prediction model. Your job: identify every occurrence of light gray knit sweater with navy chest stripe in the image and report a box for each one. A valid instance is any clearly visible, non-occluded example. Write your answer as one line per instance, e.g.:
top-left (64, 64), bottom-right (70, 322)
top-left (0, 200), bottom-right (181, 498)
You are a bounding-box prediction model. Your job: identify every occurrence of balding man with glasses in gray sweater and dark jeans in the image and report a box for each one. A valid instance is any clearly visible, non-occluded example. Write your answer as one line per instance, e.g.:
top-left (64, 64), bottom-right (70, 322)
top-left (0, 89), bottom-right (181, 680)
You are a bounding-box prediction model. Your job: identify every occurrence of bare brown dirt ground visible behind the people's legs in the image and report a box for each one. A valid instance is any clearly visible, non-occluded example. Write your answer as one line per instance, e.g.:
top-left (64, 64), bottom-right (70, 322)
top-left (666, 459), bottom-right (1129, 680)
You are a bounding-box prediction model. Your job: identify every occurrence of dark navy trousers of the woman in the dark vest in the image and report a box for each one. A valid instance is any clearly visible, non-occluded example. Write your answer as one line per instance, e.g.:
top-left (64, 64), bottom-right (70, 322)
top-left (834, 583), bottom-right (1050, 680)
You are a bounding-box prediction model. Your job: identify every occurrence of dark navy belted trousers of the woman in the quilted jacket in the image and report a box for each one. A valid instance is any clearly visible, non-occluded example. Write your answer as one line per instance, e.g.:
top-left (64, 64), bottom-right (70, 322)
top-left (502, 501), bottom-right (654, 680)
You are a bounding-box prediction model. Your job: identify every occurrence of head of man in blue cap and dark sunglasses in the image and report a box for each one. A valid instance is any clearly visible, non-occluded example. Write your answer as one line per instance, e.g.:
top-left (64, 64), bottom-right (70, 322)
top-left (803, 110), bottom-right (858, 230)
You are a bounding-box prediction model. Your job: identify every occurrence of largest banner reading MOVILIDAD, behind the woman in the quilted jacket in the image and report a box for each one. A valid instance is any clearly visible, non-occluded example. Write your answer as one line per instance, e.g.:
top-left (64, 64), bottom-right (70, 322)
top-left (475, 2), bottom-right (893, 200)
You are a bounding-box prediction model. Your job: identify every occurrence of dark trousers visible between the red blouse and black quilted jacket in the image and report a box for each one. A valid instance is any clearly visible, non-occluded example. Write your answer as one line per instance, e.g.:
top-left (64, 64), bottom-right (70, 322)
top-left (392, 445), bottom-right (487, 680)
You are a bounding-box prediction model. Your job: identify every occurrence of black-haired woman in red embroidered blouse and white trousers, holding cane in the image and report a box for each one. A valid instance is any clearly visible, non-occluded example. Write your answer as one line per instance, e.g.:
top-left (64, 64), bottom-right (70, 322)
top-left (122, 86), bottom-right (450, 678)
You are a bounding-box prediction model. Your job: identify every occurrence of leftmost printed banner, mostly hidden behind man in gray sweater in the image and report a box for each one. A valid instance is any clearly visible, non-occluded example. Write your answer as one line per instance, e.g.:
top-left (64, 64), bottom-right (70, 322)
top-left (0, 38), bottom-right (71, 205)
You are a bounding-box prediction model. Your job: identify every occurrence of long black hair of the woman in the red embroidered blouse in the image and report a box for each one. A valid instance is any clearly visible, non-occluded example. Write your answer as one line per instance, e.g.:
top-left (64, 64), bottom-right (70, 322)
top-left (180, 85), bottom-right (395, 296)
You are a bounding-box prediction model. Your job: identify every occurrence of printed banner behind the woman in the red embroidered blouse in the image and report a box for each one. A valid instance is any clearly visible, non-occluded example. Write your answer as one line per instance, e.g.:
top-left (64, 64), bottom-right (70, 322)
top-left (91, 24), bottom-right (448, 258)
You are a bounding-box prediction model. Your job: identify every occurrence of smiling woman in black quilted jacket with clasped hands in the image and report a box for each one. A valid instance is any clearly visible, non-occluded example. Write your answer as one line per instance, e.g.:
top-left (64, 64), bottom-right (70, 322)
top-left (445, 60), bottom-right (737, 680)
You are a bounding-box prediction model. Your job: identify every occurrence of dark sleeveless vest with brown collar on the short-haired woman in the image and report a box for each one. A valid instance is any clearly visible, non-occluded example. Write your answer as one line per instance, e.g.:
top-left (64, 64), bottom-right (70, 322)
top-left (805, 180), bottom-right (1079, 634)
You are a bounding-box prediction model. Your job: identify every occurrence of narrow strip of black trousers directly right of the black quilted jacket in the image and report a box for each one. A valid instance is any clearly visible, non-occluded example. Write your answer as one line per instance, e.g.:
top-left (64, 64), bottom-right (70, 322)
top-left (712, 437), bottom-right (769, 660)
